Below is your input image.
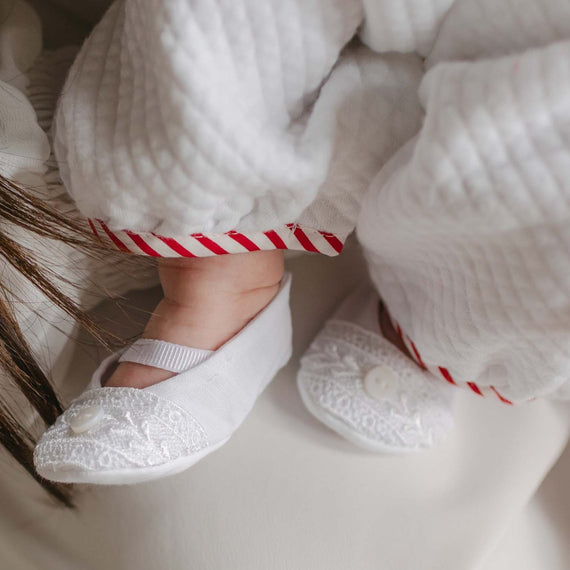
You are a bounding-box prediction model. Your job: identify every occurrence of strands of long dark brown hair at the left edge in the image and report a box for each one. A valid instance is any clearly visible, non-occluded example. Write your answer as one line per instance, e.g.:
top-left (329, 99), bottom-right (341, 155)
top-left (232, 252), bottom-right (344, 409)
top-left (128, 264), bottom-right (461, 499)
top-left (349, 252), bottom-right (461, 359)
top-left (0, 176), bottom-right (126, 506)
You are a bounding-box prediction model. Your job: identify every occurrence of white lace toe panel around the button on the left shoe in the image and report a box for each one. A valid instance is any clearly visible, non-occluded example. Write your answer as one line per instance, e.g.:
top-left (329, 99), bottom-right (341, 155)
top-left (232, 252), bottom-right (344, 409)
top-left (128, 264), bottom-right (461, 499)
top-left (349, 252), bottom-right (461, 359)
top-left (34, 388), bottom-right (209, 471)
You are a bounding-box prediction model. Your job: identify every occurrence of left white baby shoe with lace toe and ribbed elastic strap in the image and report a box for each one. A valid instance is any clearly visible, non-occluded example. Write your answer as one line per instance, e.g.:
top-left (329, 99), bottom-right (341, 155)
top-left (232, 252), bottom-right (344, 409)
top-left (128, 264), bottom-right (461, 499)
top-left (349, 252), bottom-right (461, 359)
top-left (34, 274), bottom-right (291, 485)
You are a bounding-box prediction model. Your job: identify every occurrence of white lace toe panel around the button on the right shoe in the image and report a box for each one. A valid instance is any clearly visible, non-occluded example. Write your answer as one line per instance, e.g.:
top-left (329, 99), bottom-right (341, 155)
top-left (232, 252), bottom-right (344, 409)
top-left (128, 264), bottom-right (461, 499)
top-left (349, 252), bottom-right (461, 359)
top-left (299, 320), bottom-right (452, 450)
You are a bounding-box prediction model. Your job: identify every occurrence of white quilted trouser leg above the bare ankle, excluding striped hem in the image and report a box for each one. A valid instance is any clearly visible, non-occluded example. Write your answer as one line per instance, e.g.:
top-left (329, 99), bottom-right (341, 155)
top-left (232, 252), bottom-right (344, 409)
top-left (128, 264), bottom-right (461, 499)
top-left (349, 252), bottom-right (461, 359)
top-left (52, 0), bottom-right (421, 238)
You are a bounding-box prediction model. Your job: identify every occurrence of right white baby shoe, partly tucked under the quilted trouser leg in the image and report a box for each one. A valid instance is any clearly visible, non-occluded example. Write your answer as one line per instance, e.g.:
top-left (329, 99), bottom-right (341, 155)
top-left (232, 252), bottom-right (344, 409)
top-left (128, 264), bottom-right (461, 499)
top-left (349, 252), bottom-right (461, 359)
top-left (297, 285), bottom-right (453, 453)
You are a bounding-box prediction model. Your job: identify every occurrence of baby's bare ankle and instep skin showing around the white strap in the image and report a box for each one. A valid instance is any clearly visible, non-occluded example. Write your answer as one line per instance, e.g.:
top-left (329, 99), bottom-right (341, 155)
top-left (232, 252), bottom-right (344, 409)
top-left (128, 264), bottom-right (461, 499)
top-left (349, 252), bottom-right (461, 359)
top-left (106, 250), bottom-right (284, 388)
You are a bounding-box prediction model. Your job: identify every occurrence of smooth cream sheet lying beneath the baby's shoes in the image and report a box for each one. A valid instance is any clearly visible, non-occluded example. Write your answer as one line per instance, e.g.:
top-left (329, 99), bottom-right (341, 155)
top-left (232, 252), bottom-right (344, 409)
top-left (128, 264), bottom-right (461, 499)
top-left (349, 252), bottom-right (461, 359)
top-left (0, 242), bottom-right (570, 570)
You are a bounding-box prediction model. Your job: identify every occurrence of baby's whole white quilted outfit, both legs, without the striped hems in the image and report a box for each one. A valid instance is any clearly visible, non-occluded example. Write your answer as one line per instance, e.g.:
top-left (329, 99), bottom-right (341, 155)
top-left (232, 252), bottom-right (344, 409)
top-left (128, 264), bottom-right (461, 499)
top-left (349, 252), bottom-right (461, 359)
top-left (52, 0), bottom-right (570, 401)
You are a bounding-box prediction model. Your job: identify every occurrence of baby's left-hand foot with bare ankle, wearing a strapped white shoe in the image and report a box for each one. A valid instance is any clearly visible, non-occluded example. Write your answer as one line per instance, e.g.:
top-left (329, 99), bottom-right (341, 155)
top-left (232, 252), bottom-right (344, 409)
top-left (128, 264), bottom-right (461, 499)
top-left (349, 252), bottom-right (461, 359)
top-left (34, 253), bottom-right (292, 484)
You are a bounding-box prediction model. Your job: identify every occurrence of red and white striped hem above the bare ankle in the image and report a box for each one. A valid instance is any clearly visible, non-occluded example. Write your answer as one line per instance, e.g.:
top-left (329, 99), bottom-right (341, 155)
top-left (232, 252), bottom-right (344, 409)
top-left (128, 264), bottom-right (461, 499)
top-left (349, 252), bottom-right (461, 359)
top-left (88, 219), bottom-right (346, 257)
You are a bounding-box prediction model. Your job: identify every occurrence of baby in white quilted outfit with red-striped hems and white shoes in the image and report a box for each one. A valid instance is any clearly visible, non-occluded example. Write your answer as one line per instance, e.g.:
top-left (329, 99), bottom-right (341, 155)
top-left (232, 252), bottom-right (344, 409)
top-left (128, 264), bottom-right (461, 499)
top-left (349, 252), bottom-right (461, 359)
top-left (35, 0), bottom-right (570, 483)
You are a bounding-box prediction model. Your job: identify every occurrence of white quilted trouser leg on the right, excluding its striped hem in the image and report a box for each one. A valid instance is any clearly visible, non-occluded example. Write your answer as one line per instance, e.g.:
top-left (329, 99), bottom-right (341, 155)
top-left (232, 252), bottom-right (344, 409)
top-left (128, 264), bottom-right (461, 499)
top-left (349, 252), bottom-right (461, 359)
top-left (358, 0), bottom-right (570, 401)
